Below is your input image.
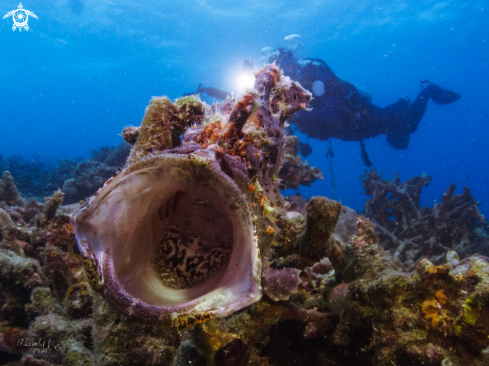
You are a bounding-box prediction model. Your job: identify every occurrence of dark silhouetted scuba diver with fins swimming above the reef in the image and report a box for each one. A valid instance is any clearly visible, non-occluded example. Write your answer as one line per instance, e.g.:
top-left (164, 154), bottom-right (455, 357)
top-left (269, 48), bottom-right (461, 149)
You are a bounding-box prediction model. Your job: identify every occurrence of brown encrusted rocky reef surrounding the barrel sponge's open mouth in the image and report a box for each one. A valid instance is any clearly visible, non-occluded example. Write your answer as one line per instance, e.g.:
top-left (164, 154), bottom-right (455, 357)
top-left (0, 69), bottom-right (489, 366)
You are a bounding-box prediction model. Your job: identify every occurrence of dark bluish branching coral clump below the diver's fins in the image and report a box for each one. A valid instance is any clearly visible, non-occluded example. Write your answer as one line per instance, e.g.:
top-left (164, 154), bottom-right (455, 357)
top-left (361, 169), bottom-right (489, 268)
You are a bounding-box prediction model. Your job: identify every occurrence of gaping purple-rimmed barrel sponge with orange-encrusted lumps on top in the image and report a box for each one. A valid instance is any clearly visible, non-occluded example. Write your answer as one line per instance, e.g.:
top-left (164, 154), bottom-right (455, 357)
top-left (75, 66), bottom-right (311, 324)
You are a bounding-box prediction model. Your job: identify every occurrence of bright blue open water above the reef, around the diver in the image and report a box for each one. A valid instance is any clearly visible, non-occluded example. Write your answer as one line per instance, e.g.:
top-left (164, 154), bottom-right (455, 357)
top-left (0, 0), bottom-right (489, 214)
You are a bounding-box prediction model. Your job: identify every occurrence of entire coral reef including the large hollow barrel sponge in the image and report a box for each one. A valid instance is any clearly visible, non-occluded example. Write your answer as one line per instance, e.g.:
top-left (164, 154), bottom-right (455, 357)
top-left (0, 66), bottom-right (489, 366)
